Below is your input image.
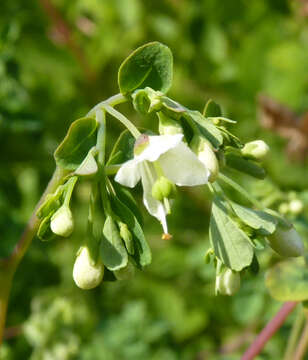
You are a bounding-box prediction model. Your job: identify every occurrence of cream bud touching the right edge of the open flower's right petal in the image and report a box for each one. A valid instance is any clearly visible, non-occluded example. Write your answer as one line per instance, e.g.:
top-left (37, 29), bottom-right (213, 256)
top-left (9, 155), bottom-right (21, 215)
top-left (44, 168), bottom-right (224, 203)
top-left (190, 135), bottom-right (219, 182)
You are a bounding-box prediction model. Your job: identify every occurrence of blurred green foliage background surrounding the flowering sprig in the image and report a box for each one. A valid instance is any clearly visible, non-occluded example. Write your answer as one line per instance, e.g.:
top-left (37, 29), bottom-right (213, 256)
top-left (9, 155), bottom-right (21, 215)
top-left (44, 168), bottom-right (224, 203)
top-left (0, 0), bottom-right (308, 360)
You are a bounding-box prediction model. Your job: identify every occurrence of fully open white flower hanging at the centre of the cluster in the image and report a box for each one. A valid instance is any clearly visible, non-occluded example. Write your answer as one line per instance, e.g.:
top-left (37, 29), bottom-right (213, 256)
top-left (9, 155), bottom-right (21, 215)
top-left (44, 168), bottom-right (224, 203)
top-left (115, 134), bottom-right (210, 234)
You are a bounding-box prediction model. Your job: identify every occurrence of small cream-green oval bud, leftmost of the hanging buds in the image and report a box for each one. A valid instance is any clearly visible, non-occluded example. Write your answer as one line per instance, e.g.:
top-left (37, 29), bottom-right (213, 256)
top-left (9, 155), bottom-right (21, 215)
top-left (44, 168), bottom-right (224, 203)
top-left (50, 205), bottom-right (74, 237)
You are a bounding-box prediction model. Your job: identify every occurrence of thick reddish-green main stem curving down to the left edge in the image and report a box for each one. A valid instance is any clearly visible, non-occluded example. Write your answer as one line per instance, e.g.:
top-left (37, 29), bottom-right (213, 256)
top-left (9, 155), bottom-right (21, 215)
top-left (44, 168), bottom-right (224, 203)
top-left (0, 168), bottom-right (67, 345)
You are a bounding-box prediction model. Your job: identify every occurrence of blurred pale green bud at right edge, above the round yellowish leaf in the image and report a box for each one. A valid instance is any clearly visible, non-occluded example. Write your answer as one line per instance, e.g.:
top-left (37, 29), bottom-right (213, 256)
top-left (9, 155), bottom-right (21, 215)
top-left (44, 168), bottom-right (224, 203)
top-left (267, 226), bottom-right (304, 257)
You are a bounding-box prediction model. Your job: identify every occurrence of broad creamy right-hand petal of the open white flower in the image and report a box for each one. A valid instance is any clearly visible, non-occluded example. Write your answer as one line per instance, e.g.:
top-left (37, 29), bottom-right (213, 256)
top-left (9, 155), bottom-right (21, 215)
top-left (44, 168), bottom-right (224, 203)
top-left (159, 142), bottom-right (210, 186)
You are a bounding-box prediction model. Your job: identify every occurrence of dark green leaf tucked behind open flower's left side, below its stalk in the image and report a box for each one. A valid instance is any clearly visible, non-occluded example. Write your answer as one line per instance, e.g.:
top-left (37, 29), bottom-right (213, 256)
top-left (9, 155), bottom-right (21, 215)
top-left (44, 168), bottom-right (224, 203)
top-left (106, 130), bottom-right (136, 165)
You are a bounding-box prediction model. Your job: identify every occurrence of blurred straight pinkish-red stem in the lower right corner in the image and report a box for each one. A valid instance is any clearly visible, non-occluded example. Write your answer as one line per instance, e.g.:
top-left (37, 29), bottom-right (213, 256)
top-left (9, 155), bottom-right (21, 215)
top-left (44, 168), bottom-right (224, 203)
top-left (241, 301), bottom-right (297, 360)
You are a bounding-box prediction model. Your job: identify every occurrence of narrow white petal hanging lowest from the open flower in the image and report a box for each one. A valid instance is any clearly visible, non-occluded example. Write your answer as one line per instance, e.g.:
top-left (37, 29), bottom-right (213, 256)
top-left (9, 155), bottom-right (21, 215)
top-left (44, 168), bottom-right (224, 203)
top-left (141, 162), bottom-right (168, 234)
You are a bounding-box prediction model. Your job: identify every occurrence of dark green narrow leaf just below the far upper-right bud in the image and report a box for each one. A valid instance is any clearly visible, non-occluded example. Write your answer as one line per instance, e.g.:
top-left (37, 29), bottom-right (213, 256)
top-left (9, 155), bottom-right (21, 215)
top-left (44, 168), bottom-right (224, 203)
top-left (225, 153), bottom-right (266, 180)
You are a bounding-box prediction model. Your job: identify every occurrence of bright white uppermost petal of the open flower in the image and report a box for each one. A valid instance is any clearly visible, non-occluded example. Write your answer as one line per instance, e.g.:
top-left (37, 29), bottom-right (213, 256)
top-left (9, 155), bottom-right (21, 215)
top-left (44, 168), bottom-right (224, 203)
top-left (135, 134), bottom-right (183, 161)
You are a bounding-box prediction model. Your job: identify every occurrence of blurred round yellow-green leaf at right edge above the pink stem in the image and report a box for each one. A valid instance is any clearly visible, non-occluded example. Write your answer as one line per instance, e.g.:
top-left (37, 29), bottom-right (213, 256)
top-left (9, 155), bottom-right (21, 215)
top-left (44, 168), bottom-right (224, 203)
top-left (265, 259), bottom-right (308, 301)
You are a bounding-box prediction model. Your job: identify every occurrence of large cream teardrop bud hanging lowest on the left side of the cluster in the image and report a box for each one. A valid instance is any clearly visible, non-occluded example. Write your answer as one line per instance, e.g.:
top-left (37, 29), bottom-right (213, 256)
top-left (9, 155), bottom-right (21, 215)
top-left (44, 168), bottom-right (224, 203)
top-left (73, 246), bottom-right (104, 290)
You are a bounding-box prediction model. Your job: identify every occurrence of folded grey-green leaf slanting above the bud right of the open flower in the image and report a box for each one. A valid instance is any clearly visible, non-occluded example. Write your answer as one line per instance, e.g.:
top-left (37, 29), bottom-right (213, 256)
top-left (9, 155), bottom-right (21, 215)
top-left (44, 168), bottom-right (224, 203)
top-left (184, 110), bottom-right (223, 148)
